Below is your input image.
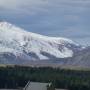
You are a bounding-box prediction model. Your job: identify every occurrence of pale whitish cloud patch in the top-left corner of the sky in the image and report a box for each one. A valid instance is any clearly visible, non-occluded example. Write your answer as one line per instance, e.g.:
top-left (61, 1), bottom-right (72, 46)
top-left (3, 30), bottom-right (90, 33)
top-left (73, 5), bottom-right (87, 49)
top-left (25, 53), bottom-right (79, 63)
top-left (0, 0), bottom-right (46, 9)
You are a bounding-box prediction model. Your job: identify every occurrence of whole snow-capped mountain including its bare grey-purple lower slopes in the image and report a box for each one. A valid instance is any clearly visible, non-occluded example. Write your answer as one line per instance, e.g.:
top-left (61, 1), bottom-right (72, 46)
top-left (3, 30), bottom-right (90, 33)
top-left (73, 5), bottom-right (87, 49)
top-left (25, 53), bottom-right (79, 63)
top-left (0, 22), bottom-right (90, 67)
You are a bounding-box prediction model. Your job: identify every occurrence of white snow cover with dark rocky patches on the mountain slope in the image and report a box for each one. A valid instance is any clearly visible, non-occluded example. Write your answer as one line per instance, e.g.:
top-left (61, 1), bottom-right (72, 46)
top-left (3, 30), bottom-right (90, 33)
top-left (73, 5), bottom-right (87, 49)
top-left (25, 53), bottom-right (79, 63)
top-left (0, 22), bottom-right (82, 60)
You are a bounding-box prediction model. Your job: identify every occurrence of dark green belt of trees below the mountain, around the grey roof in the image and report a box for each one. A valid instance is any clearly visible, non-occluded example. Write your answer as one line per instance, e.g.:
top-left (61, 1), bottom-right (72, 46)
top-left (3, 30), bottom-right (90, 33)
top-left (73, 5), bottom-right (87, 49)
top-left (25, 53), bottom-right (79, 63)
top-left (0, 66), bottom-right (90, 90)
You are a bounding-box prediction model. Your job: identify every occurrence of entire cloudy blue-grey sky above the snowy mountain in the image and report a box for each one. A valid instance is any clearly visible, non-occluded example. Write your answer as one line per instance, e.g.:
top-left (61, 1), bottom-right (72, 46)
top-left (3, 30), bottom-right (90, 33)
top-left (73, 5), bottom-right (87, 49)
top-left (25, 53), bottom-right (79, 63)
top-left (0, 0), bottom-right (90, 45)
